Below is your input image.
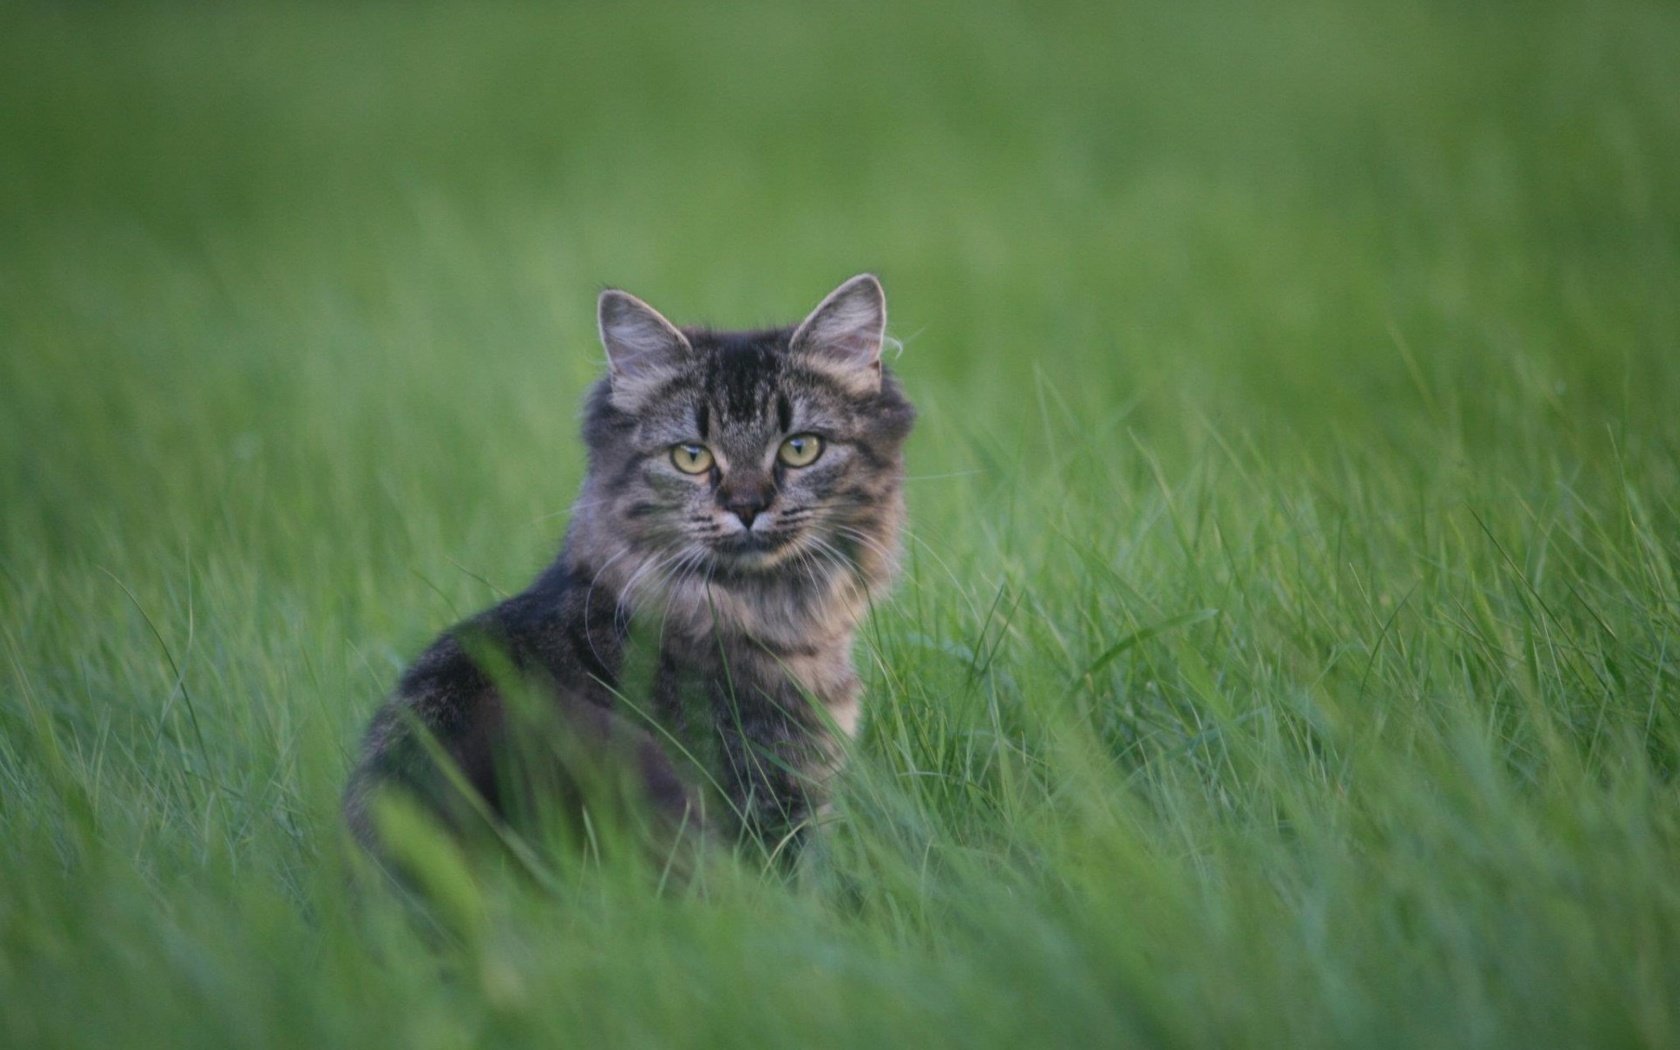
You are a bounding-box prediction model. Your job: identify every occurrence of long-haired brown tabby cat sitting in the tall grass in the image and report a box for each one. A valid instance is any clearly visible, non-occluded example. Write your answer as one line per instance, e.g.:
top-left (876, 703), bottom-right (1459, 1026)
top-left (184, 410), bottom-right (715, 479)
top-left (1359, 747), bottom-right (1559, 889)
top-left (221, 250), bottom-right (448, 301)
top-left (344, 274), bottom-right (916, 855)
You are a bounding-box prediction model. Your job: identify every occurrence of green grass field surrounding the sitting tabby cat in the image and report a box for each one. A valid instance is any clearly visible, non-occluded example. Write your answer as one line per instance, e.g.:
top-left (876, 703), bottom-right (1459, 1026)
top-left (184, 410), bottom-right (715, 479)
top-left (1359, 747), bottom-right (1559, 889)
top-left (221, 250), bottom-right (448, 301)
top-left (0, 0), bottom-right (1680, 1048)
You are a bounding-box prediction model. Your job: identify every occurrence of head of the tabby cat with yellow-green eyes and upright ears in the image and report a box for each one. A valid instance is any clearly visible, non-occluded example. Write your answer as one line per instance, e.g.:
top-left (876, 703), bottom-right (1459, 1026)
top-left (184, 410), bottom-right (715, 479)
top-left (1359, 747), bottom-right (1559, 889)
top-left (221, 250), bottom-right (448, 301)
top-left (585, 274), bottom-right (916, 594)
